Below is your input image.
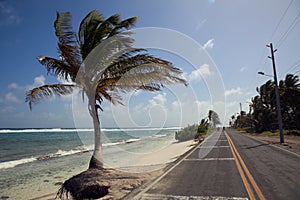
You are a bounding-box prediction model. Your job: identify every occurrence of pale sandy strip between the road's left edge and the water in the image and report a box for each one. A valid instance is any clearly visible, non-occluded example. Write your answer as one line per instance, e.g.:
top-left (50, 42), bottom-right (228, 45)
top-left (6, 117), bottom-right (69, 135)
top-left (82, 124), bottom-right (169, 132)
top-left (31, 140), bottom-right (195, 200)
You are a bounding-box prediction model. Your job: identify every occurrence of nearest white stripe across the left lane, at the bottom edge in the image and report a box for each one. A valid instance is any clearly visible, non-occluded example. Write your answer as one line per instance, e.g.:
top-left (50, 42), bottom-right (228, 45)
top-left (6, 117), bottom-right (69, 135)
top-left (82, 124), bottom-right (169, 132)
top-left (141, 193), bottom-right (248, 200)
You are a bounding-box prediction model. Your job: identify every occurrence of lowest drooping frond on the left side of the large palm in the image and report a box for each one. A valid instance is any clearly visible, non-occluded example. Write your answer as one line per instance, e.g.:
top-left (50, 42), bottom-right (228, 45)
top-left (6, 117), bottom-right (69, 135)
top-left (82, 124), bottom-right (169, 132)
top-left (25, 84), bottom-right (76, 110)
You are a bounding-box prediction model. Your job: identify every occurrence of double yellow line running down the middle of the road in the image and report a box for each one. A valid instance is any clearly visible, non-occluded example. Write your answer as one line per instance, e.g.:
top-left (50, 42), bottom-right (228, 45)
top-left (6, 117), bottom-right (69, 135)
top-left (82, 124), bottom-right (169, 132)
top-left (224, 131), bottom-right (266, 200)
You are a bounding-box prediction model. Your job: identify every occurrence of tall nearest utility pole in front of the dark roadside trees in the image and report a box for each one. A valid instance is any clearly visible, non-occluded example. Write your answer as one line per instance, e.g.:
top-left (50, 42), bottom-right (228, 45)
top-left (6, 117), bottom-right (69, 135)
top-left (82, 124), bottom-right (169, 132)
top-left (267, 43), bottom-right (284, 144)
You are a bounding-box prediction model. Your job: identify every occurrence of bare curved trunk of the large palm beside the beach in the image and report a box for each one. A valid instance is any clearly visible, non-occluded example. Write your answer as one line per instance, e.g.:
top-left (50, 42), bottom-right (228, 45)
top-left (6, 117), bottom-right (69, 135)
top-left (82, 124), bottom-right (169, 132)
top-left (89, 103), bottom-right (103, 169)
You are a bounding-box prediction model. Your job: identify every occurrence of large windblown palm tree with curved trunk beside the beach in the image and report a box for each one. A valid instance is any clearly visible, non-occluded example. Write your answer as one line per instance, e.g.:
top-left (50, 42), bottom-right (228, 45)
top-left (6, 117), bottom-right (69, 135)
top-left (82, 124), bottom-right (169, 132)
top-left (26, 10), bottom-right (187, 169)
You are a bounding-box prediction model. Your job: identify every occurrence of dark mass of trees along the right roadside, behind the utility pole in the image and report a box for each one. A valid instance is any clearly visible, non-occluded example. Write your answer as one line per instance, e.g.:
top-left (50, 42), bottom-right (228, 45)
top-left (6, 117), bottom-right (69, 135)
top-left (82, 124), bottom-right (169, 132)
top-left (229, 74), bottom-right (300, 136)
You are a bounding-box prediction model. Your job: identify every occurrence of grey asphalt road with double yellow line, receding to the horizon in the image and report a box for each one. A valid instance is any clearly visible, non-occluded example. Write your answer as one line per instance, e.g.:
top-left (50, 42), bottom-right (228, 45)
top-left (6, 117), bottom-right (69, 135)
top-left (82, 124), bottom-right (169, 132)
top-left (135, 130), bottom-right (300, 200)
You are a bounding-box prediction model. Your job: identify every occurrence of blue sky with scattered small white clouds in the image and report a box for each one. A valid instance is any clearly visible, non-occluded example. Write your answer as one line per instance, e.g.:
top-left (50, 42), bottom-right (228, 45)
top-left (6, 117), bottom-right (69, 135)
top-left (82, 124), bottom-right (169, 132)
top-left (0, 0), bottom-right (300, 128)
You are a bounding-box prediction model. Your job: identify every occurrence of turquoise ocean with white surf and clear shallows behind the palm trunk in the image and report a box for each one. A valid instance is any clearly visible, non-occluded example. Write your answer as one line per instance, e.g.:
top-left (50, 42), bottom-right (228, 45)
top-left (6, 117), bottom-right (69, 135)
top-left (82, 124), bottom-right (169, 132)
top-left (0, 127), bottom-right (180, 199)
